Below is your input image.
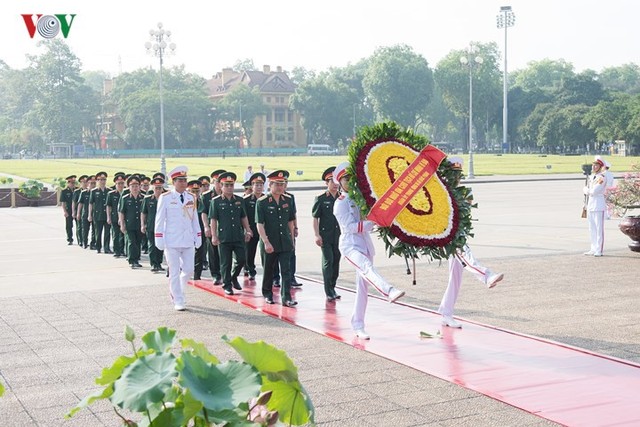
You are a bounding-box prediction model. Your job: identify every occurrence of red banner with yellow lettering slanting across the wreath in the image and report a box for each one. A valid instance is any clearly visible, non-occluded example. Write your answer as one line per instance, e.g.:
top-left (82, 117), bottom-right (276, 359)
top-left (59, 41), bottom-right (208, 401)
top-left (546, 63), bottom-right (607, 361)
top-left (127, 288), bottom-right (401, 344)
top-left (367, 145), bottom-right (447, 227)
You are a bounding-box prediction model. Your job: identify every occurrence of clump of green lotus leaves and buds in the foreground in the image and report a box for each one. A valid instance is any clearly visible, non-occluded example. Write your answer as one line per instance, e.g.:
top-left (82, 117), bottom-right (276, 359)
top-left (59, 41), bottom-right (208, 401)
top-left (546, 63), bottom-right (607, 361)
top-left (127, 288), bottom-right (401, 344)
top-left (66, 326), bottom-right (315, 427)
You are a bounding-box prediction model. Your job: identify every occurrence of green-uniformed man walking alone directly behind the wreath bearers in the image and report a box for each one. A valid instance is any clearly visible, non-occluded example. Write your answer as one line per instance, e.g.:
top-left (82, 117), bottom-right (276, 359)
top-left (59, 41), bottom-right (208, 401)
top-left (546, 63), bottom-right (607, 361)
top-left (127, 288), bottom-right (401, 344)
top-left (311, 166), bottom-right (340, 301)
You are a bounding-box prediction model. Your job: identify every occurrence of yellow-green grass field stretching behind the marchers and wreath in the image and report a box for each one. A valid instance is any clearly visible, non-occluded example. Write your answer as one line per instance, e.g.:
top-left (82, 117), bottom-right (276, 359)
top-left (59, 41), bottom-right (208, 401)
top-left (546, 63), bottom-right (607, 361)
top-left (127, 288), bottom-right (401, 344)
top-left (0, 154), bottom-right (640, 183)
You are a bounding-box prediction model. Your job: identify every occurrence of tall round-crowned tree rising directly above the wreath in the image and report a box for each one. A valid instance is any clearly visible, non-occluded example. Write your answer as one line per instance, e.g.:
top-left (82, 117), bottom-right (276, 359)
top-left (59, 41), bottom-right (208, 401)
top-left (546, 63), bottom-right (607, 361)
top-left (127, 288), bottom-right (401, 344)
top-left (362, 45), bottom-right (433, 128)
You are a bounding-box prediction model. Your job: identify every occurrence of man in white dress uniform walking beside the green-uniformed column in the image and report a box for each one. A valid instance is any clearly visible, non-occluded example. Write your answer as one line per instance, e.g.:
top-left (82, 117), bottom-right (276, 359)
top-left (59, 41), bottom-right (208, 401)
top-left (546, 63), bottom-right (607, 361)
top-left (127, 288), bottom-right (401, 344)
top-left (155, 166), bottom-right (202, 311)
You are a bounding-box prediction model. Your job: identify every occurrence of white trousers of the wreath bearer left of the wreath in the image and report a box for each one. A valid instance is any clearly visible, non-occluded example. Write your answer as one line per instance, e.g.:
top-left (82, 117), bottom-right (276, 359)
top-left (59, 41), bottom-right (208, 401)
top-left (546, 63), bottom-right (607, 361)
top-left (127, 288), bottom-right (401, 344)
top-left (342, 249), bottom-right (391, 330)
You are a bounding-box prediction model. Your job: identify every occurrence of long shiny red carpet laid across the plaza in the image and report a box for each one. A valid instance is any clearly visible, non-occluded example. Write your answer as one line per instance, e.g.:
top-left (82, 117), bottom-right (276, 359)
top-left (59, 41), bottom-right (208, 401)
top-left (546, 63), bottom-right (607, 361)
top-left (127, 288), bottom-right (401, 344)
top-left (191, 277), bottom-right (640, 426)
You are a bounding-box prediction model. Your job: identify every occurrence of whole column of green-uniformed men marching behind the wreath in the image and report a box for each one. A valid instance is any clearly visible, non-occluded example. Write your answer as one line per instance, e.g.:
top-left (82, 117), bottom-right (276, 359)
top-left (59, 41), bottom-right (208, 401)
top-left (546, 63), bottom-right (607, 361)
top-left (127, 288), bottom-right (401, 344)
top-left (61, 168), bottom-right (340, 309)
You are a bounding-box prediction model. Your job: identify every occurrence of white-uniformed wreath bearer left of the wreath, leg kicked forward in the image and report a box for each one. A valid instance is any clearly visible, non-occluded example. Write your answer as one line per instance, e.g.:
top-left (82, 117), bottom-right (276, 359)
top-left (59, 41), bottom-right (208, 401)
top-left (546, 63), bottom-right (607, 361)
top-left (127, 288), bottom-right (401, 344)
top-left (333, 162), bottom-right (404, 340)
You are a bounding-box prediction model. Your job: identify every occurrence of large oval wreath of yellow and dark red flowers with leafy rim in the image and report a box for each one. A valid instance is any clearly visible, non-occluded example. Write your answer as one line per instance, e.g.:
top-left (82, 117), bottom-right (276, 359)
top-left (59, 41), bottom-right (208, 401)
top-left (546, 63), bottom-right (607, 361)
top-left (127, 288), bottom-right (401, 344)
top-left (348, 122), bottom-right (475, 260)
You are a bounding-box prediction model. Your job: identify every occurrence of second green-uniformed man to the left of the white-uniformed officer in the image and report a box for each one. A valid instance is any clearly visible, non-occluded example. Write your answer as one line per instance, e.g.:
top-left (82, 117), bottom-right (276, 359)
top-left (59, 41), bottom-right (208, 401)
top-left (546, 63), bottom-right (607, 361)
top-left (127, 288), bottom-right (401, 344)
top-left (118, 175), bottom-right (144, 268)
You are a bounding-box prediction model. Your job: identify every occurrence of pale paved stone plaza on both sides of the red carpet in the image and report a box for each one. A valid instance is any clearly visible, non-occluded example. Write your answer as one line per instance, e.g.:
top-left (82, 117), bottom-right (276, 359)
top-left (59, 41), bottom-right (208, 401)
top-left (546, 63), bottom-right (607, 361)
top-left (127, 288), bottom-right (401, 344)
top-left (0, 175), bottom-right (640, 426)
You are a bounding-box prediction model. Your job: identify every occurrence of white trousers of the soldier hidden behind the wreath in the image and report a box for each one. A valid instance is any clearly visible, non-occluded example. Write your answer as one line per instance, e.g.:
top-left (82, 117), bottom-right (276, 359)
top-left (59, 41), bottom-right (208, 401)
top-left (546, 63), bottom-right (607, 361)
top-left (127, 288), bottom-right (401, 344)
top-left (438, 245), bottom-right (491, 316)
